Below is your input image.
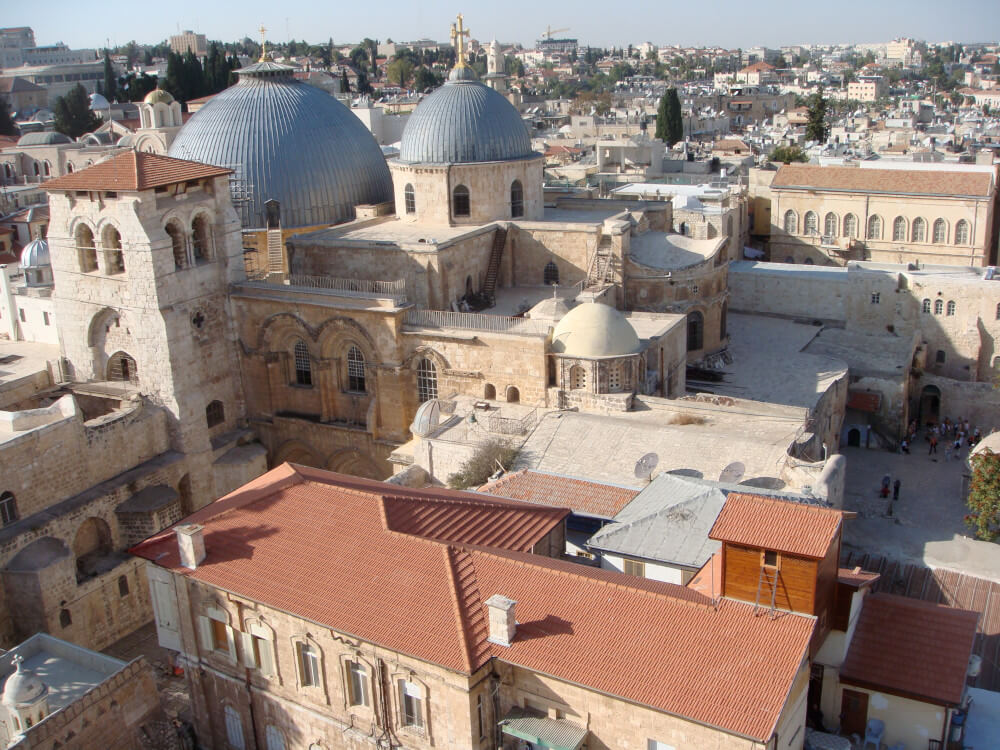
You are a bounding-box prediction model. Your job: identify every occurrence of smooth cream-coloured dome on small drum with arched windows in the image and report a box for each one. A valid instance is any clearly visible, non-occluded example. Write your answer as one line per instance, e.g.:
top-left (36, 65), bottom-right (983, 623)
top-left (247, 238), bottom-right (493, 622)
top-left (552, 302), bottom-right (642, 358)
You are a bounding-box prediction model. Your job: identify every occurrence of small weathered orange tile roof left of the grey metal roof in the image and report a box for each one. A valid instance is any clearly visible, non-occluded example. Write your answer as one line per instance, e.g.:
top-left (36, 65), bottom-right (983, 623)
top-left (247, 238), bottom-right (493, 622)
top-left (479, 469), bottom-right (639, 518)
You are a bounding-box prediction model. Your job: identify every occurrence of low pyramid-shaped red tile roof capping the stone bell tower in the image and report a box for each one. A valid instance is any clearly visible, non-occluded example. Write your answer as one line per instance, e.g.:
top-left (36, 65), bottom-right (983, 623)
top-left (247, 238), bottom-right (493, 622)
top-left (45, 151), bottom-right (232, 192)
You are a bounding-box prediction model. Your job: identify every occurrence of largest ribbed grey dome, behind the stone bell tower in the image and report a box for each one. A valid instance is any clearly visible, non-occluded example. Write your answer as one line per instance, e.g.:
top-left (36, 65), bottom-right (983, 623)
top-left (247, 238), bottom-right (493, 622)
top-left (169, 62), bottom-right (392, 228)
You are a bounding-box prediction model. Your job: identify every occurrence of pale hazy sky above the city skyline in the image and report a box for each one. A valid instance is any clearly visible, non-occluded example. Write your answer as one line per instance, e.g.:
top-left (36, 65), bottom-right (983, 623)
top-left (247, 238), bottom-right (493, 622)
top-left (13, 0), bottom-right (1000, 47)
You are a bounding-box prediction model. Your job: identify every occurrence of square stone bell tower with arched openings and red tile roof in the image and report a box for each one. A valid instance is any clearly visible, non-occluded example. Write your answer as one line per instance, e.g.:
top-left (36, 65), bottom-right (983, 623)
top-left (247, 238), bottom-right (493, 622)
top-left (45, 151), bottom-right (263, 509)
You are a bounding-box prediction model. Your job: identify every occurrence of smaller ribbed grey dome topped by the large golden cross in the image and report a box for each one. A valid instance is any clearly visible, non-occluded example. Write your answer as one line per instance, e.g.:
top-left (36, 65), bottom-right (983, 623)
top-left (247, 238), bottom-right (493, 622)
top-left (399, 68), bottom-right (536, 164)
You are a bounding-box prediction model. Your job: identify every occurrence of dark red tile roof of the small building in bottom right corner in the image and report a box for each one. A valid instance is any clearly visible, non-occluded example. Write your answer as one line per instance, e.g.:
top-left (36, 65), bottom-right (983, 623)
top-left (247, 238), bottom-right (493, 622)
top-left (840, 594), bottom-right (979, 706)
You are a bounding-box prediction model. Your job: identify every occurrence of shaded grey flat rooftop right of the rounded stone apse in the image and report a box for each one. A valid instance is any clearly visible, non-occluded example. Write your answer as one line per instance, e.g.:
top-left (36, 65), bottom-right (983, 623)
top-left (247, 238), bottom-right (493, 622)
top-left (689, 313), bottom-right (852, 410)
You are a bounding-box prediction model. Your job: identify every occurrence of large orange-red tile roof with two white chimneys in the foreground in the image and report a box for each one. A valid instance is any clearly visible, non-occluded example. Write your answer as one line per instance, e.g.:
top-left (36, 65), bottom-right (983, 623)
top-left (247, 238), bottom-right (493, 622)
top-left (133, 464), bottom-right (815, 741)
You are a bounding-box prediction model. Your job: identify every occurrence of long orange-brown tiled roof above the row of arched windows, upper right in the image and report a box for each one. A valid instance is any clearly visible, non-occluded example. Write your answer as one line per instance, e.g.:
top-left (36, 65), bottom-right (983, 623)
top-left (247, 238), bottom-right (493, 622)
top-left (771, 164), bottom-right (993, 198)
